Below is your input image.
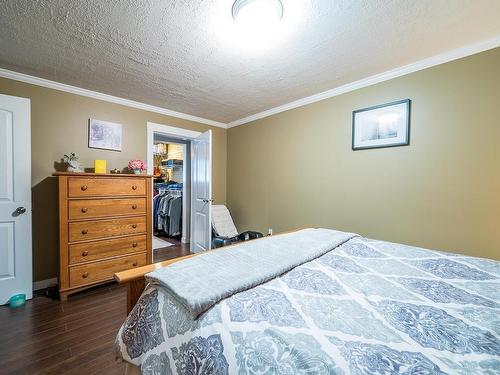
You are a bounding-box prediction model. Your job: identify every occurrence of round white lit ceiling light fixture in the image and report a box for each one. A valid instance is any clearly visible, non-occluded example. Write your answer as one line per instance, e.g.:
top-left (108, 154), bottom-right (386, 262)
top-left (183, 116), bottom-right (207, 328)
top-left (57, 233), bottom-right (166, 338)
top-left (232, 0), bottom-right (283, 25)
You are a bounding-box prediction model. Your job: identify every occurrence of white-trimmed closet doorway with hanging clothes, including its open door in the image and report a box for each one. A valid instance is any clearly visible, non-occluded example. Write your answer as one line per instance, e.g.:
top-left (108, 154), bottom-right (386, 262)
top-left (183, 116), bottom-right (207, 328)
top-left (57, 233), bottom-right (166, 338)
top-left (147, 122), bottom-right (212, 261)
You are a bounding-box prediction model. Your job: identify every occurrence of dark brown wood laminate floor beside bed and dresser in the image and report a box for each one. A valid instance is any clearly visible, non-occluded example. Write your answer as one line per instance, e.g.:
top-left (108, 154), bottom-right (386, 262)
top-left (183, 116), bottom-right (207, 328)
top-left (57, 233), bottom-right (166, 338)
top-left (0, 243), bottom-right (189, 375)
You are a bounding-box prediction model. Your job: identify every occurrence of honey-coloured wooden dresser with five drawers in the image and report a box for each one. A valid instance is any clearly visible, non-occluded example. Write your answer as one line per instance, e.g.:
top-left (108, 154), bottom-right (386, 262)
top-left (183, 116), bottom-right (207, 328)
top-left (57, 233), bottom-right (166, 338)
top-left (54, 173), bottom-right (153, 301)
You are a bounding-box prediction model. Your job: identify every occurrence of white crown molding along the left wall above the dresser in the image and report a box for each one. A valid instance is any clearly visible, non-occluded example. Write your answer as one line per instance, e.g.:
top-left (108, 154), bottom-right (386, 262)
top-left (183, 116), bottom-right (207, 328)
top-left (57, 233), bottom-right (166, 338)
top-left (0, 68), bottom-right (227, 129)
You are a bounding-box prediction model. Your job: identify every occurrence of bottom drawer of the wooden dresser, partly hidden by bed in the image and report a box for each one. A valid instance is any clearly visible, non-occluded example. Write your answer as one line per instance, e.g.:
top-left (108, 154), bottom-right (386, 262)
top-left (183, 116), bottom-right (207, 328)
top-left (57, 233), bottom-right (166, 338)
top-left (69, 254), bottom-right (146, 288)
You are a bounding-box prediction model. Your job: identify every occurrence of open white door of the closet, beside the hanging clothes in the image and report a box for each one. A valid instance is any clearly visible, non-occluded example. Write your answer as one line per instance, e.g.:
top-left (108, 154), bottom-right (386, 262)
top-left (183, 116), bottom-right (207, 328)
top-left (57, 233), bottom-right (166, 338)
top-left (191, 130), bottom-right (212, 253)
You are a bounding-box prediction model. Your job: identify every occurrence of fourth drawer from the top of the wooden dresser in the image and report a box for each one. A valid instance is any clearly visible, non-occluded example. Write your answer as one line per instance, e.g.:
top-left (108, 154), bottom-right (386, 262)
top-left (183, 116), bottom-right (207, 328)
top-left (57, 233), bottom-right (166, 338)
top-left (69, 234), bottom-right (146, 264)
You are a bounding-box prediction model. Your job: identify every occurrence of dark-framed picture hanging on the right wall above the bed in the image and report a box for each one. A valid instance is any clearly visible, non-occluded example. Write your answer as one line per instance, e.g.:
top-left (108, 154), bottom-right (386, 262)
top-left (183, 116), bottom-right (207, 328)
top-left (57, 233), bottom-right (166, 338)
top-left (352, 99), bottom-right (411, 150)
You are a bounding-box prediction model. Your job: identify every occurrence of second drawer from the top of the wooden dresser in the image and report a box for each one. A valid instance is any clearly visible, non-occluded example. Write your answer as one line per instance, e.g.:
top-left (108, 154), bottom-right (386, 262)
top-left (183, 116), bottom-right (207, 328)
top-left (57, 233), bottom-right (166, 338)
top-left (68, 198), bottom-right (146, 220)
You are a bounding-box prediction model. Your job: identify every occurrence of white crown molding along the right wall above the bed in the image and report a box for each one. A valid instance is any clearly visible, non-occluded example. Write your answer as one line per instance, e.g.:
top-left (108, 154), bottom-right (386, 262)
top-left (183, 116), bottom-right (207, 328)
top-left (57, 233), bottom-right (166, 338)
top-left (227, 35), bottom-right (500, 128)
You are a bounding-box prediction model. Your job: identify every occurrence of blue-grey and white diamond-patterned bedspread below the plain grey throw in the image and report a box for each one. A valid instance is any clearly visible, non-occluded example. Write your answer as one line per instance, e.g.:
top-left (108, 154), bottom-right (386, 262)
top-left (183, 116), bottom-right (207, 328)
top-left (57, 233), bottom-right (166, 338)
top-left (116, 237), bottom-right (500, 375)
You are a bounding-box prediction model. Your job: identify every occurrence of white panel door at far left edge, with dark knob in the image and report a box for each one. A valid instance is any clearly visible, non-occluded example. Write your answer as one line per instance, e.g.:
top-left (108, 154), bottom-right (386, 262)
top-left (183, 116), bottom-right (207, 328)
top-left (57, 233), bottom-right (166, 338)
top-left (0, 95), bottom-right (33, 305)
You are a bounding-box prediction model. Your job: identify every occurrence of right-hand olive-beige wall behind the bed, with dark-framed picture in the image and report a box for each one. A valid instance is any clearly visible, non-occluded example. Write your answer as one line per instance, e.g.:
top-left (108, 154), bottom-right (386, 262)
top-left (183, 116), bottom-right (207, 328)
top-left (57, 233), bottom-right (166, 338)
top-left (228, 48), bottom-right (500, 259)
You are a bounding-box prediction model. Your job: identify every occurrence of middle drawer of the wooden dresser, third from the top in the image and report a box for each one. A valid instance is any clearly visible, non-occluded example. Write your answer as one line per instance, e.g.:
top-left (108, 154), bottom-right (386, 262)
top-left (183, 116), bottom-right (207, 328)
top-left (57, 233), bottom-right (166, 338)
top-left (68, 216), bottom-right (146, 242)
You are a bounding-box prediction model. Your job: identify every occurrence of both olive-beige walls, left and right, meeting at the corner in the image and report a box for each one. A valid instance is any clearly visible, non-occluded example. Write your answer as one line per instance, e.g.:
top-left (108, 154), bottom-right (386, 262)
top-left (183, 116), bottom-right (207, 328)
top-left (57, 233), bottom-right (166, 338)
top-left (0, 48), bottom-right (500, 280)
